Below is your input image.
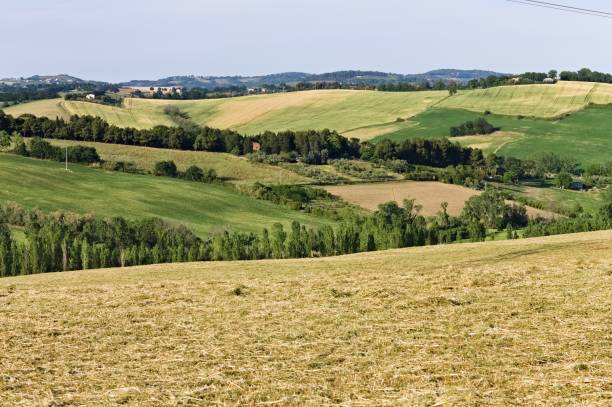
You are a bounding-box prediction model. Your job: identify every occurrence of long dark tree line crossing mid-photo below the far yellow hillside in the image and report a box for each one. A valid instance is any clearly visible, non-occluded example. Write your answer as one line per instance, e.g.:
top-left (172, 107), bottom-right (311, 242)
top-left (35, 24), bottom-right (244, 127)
top-left (0, 112), bottom-right (482, 166)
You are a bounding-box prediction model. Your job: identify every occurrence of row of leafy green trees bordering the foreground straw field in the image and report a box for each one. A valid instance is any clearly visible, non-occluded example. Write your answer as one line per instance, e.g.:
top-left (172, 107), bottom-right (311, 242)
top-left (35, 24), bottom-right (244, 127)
top-left (0, 190), bottom-right (536, 276)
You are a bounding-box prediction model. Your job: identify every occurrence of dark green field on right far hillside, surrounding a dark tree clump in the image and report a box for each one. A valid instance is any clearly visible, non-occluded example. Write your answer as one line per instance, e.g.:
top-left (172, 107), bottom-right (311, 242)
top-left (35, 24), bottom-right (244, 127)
top-left (374, 105), bottom-right (612, 164)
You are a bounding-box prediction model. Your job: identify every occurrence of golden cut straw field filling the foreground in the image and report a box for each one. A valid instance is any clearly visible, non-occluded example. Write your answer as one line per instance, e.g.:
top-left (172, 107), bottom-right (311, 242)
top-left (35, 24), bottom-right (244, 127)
top-left (0, 231), bottom-right (612, 406)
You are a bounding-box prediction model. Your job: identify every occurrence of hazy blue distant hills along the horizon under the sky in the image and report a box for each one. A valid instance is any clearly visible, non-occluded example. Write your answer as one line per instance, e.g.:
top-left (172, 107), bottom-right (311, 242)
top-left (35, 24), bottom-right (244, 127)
top-left (122, 69), bottom-right (505, 89)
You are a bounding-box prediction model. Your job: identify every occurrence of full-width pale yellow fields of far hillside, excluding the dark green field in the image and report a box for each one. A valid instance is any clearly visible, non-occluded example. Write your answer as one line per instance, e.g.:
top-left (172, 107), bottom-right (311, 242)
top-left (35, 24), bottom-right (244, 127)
top-left (5, 82), bottom-right (612, 139)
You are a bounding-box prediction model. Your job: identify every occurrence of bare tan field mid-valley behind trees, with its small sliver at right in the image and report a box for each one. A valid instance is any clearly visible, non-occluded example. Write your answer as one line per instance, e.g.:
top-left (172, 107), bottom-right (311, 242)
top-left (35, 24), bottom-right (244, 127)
top-left (325, 181), bottom-right (555, 218)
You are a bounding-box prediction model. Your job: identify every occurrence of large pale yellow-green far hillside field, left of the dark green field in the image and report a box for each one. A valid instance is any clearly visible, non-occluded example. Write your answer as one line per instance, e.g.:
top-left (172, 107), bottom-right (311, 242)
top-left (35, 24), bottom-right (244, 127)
top-left (4, 90), bottom-right (448, 134)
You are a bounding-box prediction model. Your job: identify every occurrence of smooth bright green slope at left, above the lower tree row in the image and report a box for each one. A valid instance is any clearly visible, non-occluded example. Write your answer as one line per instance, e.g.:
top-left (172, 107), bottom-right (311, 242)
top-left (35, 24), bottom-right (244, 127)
top-left (0, 154), bottom-right (326, 235)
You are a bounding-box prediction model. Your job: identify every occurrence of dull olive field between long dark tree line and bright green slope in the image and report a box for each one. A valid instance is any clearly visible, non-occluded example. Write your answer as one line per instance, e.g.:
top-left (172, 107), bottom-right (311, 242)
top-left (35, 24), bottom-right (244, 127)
top-left (42, 139), bottom-right (313, 184)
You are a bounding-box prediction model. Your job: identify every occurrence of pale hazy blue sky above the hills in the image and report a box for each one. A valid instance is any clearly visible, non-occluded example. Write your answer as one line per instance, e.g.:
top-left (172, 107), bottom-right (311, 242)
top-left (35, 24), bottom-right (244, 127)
top-left (0, 0), bottom-right (612, 81)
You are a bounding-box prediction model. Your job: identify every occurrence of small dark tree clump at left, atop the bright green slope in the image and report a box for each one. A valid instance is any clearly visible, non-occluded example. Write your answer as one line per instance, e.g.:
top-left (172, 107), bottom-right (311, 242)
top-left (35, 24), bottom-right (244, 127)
top-left (14, 137), bottom-right (101, 164)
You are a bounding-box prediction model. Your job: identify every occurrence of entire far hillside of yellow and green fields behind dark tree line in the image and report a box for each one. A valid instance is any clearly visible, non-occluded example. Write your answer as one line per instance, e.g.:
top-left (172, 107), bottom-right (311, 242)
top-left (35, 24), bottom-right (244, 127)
top-left (5, 82), bottom-right (612, 163)
